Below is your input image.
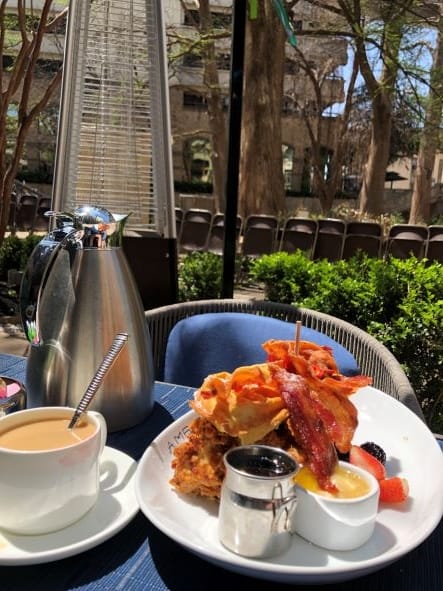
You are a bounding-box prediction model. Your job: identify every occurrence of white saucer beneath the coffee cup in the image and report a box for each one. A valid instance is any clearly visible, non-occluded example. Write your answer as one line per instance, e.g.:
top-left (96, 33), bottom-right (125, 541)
top-left (0, 447), bottom-right (139, 565)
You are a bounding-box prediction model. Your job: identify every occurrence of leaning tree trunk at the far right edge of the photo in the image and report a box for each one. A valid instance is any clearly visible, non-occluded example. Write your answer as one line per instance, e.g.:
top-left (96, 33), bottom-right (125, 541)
top-left (409, 19), bottom-right (443, 224)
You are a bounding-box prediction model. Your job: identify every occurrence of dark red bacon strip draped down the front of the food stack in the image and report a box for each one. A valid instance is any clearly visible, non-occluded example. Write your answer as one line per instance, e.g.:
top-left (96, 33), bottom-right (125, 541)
top-left (275, 369), bottom-right (337, 492)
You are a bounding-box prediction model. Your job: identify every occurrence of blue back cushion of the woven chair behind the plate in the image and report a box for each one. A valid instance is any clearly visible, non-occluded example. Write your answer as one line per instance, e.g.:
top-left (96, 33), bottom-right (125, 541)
top-left (163, 312), bottom-right (360, 388)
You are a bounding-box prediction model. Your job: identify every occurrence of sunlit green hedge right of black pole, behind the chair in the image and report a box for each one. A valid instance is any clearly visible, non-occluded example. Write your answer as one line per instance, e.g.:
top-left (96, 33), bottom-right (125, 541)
top-left (251, 252), bottom-right (443, 432)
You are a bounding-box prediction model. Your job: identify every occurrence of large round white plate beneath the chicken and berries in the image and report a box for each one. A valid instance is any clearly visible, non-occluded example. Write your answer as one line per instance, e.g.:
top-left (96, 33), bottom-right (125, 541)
top-left (135, 386), bottom-right (443, 583)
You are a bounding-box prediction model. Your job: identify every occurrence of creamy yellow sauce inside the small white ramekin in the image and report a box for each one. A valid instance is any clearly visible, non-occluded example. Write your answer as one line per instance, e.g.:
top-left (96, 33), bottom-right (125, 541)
top-left (294, 466), bottom-right (370, 499)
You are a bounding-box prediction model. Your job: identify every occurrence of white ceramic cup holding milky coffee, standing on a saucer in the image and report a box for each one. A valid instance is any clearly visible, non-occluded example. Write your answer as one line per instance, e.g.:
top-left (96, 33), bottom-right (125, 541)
top-left (0, 407), bottom-right (107, 534)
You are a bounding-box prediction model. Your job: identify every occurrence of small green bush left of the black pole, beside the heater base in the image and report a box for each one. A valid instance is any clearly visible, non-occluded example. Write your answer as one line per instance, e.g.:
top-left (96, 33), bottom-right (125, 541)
top-left (178, 252), bottom-right (223, 302)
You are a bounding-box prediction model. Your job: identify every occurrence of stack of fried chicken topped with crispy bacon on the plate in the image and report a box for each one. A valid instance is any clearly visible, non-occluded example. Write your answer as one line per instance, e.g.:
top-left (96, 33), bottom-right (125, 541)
top-left (170, 341), bottom-right (371, 499)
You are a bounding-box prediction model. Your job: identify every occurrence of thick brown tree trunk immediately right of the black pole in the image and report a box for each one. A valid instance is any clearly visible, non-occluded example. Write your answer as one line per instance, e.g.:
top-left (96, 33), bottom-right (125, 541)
top-left (239, 0), bottom-right (286, 217)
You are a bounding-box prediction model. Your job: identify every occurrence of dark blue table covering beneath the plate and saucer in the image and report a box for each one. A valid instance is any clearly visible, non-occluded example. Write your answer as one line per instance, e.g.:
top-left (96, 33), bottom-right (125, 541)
top-left (0, 355), bottom-right (443, 591)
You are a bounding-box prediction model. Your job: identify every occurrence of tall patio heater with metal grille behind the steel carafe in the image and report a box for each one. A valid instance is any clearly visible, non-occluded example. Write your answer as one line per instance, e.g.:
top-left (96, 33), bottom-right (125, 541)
top-left (53, 0), bottom-right (177, 309)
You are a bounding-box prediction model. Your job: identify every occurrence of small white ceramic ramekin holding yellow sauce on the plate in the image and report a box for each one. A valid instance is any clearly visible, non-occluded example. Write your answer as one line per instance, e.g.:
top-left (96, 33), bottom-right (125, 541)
top-left (293, 462), bottom-right (380, 550)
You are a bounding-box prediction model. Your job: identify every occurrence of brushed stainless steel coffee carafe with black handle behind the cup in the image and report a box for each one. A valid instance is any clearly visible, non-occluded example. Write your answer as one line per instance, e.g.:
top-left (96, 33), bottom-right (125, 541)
top-left (20, 206), bottom-right (154, 431)
